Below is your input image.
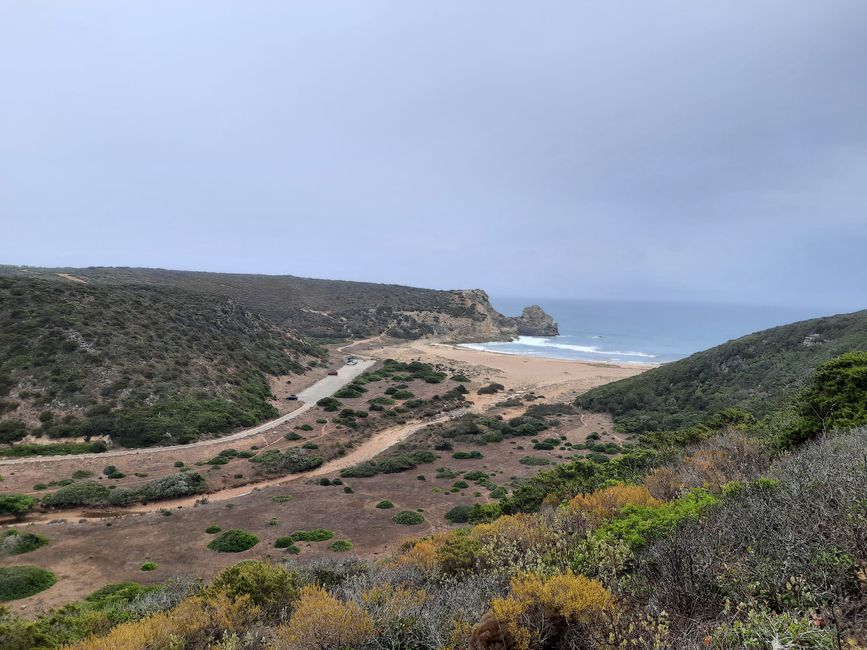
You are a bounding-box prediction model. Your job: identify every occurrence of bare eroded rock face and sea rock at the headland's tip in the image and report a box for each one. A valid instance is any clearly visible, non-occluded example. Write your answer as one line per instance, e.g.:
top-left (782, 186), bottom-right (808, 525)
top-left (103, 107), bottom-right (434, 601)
top-left (389, 289), bottom-right (558, 343)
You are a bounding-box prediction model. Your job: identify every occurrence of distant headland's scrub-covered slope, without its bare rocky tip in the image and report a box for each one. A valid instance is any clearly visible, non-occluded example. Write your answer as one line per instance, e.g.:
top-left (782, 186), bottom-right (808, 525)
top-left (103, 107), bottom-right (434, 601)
top-left (0, 266), bottom-right (499, 338)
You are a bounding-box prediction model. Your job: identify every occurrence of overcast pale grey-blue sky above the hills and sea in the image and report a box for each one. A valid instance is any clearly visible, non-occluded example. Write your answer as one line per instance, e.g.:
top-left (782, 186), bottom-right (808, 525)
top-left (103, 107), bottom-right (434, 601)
top-left (0, 0), bottom-right (867, 309)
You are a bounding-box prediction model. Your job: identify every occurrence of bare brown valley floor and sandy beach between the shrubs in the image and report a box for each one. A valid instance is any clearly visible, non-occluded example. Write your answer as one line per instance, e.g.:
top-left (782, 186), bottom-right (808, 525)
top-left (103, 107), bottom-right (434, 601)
top-left (0, 337), bottom-right (644, 613)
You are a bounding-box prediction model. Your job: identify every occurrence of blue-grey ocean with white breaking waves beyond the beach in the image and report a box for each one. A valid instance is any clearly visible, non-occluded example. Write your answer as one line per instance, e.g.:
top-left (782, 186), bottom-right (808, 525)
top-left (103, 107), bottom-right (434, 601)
top-left (464, 297), bottom-right (844, 364)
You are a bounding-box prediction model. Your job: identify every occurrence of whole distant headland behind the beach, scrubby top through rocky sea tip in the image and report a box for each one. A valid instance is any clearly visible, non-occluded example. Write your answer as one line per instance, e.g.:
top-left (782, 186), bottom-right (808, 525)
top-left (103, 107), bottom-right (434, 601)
top-left (0, 266), bottom-right (557, 342)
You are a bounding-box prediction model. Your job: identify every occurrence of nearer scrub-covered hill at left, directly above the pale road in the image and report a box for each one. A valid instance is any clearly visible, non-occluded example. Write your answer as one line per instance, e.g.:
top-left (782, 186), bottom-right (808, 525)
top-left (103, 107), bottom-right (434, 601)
top-left (0, 277), bottom-right (317, 446)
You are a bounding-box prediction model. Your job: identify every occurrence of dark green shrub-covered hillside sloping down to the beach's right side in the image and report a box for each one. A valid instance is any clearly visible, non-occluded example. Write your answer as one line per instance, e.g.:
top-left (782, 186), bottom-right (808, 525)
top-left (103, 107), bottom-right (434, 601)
top-left (576, 311), bottom-right (867, 432)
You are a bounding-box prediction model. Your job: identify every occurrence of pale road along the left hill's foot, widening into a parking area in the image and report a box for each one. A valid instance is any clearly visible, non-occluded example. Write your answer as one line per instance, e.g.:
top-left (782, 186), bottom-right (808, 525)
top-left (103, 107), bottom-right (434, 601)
top-left (0, 359), bottom-right (376, 466)
